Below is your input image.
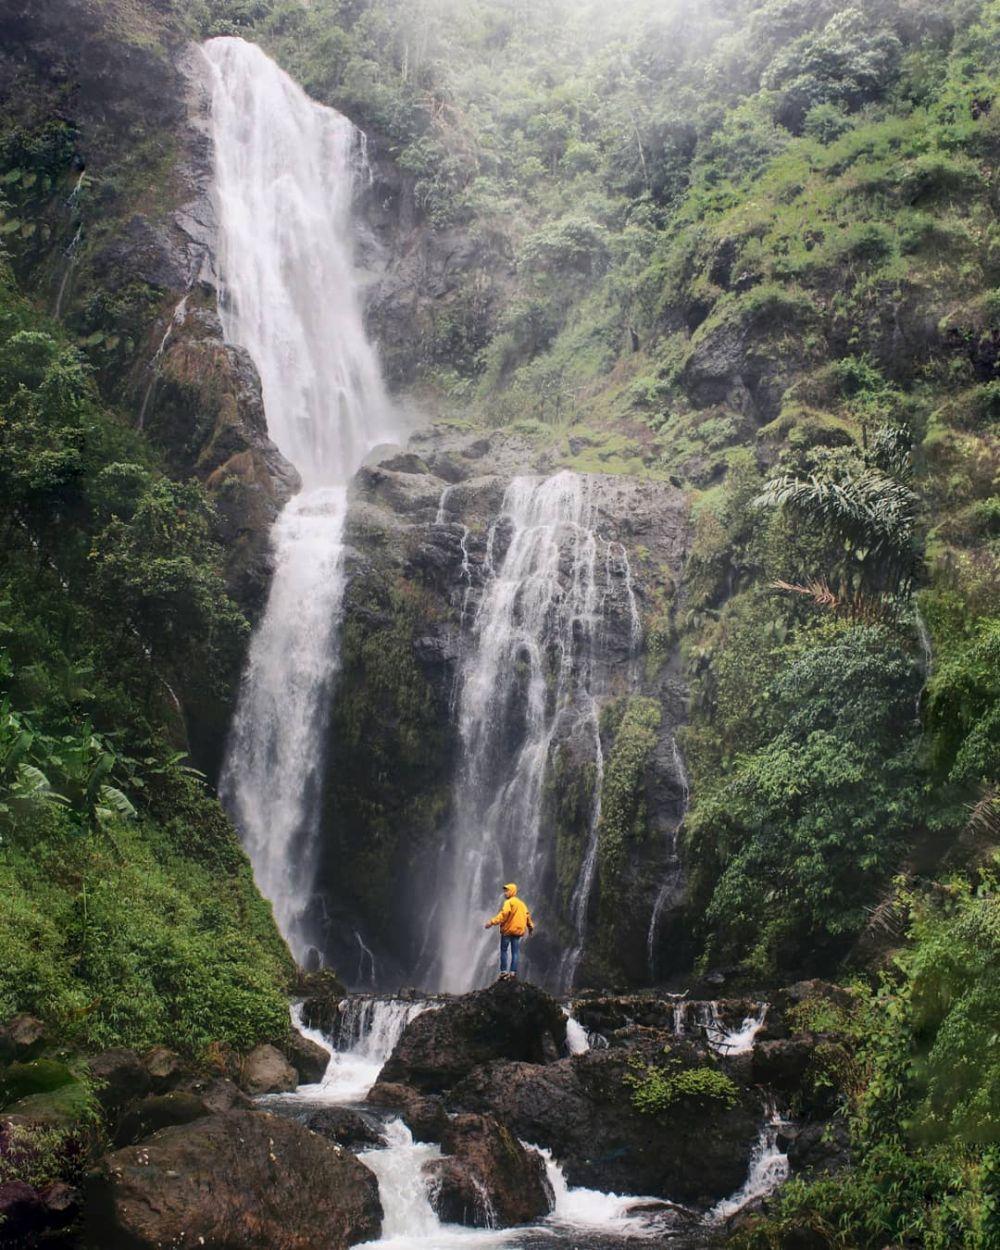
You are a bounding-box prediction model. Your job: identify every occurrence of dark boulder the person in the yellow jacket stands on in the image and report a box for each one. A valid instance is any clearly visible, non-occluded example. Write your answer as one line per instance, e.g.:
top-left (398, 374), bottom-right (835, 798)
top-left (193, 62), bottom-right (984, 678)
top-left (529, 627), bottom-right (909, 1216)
top-left (379, 981), bottom-right (566, 1094)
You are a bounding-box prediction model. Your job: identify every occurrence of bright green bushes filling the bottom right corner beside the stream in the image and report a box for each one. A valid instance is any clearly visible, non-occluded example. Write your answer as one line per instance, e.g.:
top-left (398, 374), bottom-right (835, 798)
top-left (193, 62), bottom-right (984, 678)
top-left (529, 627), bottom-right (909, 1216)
top-left (735, 873), bottom-right (1000, 1250)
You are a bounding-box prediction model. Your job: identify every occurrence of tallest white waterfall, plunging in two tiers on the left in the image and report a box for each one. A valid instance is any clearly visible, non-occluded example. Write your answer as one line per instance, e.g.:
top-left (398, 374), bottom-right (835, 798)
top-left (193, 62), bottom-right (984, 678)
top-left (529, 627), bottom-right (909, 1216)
top-left (205, 39), bottom-right (396, 960)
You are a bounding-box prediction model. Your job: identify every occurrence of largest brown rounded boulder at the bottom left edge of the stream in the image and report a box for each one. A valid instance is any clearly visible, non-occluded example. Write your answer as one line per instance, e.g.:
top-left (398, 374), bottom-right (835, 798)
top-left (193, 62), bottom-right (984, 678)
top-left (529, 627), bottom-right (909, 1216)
top-left (84, 1111), bottom-right (381, 1250)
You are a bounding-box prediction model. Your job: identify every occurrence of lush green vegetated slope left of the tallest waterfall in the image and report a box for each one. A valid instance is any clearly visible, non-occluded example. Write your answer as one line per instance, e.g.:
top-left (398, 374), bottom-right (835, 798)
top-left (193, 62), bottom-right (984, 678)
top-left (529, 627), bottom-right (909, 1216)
top-left (0, 274), bottom-right (289, 1056)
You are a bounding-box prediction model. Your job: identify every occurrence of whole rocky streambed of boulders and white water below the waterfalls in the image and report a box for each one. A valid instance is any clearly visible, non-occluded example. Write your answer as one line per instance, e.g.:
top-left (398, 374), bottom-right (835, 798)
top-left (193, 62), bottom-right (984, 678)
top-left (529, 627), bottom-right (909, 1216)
top-left (0, 983), bottom-right (844, 1250)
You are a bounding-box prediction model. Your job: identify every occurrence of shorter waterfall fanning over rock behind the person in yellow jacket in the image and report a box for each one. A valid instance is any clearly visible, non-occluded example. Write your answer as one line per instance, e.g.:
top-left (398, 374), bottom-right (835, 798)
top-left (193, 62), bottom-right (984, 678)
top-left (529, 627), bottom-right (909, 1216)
top-left (435, 473), bottom-right (638, 991)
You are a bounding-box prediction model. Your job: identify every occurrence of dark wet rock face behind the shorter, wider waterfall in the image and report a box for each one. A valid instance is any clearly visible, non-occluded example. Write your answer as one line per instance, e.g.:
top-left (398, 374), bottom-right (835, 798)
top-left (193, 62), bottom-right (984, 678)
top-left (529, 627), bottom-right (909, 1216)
top-left (320, 425), bottom-right (690, 986)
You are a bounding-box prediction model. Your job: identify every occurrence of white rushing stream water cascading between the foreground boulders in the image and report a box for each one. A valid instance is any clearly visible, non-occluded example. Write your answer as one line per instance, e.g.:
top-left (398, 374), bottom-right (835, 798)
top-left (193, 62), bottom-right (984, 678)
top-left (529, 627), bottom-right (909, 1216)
top-left (260, 996), bottom-right (788, 1250)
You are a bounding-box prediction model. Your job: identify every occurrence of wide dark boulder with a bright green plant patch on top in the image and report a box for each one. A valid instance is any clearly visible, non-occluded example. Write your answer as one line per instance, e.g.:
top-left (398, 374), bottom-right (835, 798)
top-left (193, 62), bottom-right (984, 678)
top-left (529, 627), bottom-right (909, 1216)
top-left (449, 1034), bottom-right (761, 1208)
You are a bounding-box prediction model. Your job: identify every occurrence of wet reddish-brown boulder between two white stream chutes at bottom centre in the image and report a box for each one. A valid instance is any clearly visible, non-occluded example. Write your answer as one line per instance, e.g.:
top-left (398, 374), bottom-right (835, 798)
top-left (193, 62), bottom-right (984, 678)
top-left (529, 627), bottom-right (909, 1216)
top-left (424, 1115), bottom-right (554, 1229)
